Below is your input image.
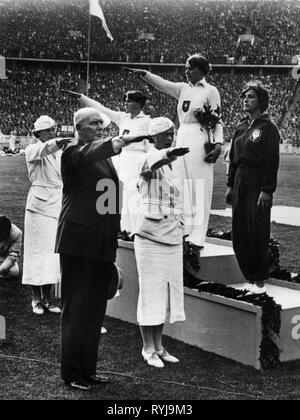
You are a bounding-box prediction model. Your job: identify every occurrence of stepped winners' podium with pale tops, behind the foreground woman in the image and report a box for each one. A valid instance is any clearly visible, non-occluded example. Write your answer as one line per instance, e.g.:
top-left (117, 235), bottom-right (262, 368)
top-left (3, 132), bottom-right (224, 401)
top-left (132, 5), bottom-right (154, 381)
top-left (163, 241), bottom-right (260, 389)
top-left (107, 239), bottom-right (300, 369)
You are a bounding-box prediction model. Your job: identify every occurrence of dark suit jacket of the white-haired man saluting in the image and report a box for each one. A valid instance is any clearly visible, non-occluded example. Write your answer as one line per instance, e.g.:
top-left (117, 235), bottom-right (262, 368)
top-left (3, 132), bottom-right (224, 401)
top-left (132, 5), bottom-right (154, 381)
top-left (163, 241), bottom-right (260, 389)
top-left (56, 140), bottom-right (120, 262)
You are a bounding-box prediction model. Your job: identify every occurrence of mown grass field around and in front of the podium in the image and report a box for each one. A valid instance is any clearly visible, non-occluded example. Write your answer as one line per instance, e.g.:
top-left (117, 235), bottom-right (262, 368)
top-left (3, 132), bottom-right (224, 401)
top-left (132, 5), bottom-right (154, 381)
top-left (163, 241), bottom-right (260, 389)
top-left (0, 156), bottom-right (300, 400)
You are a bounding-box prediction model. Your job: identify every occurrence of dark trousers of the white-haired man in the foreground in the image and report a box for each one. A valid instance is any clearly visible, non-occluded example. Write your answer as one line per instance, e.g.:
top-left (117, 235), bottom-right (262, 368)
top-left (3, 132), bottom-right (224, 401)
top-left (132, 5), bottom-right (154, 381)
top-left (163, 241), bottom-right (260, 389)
top-left (60, 255), bottom-right (113, 383)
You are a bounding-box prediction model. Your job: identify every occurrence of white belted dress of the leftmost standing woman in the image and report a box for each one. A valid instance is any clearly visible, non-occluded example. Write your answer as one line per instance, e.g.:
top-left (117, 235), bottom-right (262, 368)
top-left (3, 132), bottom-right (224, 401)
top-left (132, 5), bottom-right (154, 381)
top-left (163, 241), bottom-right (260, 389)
top-left (22, 139), bottom-right (62, 286)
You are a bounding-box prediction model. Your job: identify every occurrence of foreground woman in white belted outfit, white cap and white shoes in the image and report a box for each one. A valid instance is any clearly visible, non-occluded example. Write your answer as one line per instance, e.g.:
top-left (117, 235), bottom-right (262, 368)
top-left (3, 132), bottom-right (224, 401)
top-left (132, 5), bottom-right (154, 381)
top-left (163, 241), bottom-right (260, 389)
top-left (134, 117), bottom-right (189, 368)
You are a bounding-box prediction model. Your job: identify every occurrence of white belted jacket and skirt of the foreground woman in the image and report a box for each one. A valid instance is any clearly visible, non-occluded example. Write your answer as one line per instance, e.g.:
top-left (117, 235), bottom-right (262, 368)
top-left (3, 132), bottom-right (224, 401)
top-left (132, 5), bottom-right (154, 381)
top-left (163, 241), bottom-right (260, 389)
top-left (134, 149), bottom-right (186, 326)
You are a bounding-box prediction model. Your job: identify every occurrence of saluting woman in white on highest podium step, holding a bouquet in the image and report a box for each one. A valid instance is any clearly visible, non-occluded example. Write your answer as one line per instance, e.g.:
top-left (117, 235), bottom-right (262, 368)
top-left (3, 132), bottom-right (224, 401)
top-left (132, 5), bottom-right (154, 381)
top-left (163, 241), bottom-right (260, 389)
top-left (128, 54), bottom-right (223, 247)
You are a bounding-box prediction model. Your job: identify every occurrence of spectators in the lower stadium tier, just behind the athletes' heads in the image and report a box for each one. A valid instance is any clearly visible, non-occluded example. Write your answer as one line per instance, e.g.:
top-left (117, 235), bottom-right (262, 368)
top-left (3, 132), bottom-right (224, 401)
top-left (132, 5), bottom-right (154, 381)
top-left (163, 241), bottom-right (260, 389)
top-left (0, 63), bottom-right (300, 145)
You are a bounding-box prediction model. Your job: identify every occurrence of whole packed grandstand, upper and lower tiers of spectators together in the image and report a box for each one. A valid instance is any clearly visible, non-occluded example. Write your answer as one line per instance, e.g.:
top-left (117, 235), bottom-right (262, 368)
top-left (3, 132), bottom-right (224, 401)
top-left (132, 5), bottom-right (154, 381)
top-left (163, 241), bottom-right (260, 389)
top-left (0, 0), bottom-right (300, 146)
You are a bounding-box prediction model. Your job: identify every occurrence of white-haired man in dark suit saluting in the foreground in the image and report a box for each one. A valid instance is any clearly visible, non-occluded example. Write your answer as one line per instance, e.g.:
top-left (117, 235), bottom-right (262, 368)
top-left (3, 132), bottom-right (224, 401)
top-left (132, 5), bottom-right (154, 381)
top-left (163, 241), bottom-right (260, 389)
top-left (56, 108), bottom-right (146, 390)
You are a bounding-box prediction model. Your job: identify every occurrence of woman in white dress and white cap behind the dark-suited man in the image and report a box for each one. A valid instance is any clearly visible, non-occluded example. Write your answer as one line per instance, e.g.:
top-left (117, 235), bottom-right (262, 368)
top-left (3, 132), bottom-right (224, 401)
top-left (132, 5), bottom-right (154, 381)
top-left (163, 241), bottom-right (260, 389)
top-left (22, 115), bottom-right (70, 315)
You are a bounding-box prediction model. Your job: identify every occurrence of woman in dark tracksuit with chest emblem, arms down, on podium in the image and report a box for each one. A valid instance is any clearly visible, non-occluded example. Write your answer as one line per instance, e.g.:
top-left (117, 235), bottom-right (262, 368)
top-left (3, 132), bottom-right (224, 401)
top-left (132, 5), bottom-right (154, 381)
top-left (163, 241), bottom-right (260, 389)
top-left (226, 82), bottom-right (280, 293)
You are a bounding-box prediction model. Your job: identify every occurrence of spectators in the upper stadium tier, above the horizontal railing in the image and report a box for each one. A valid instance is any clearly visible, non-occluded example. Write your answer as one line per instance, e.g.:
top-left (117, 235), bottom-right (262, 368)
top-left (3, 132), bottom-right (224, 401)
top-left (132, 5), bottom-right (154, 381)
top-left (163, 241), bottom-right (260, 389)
top-left (0, 0), bottom-right (300, 64)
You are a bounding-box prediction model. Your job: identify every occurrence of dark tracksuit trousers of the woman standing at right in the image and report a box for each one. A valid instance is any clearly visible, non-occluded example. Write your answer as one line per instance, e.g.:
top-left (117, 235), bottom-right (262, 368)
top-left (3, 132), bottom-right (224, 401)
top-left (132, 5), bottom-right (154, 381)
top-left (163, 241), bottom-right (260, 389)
top-left (232, 169), bottom-right (271, 283)
